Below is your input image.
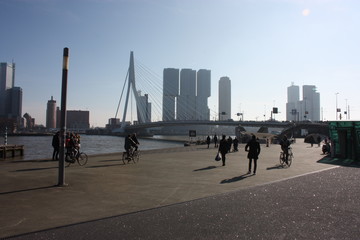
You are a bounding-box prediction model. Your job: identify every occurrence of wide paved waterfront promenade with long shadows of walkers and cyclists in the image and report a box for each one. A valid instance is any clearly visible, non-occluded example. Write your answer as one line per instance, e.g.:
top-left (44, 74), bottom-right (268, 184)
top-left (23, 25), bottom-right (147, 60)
top-left (0, 139), bottom-right (360, 239)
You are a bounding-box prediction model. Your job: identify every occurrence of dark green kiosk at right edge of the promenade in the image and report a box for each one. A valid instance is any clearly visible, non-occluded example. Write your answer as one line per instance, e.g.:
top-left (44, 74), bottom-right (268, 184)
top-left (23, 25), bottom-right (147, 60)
top-left (329, 121), bottom-right (360, 161)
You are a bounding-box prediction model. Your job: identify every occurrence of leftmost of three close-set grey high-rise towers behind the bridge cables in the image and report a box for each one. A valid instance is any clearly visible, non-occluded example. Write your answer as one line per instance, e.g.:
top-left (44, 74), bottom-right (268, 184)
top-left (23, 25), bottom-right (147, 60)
top-left (162, 68), bottom-right (179, 121)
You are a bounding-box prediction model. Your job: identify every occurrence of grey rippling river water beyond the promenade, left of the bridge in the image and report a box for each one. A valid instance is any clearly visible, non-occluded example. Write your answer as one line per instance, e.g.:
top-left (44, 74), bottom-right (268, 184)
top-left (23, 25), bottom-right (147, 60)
top-left (7, 135), bottom-right (184, 160)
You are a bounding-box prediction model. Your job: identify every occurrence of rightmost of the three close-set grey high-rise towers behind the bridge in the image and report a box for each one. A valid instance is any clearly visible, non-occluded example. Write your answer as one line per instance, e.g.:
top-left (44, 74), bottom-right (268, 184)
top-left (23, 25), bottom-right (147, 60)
top-left (196, 69), bottom-right (211, 120)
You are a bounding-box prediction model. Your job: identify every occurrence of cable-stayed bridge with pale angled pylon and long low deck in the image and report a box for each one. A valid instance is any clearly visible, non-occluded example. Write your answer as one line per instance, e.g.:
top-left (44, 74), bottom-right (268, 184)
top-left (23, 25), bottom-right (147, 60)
top-left (113, 52), bottom-right (328, 134)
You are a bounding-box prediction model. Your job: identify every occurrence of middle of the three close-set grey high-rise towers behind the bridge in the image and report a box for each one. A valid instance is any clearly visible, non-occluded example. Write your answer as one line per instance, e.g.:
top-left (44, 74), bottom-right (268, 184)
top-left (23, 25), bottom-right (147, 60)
top-left (176, 69), bottom-right (196, 120)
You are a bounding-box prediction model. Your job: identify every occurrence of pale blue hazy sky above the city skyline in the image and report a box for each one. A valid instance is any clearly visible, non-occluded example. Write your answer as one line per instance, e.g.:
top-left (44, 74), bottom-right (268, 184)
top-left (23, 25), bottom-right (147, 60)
top-left (0, 0), bottom-right (360, 127)
